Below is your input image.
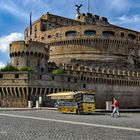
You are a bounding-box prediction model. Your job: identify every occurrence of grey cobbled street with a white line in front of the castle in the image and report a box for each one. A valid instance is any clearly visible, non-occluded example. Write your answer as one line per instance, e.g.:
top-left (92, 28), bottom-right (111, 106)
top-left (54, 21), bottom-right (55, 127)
top-left (0, 110), bottom-right (140, 140)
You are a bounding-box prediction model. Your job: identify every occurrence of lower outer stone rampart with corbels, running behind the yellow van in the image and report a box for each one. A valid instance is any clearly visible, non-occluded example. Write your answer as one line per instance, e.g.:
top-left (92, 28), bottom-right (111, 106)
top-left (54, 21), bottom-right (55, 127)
top-left (0, 64), bottom-right (140, 108)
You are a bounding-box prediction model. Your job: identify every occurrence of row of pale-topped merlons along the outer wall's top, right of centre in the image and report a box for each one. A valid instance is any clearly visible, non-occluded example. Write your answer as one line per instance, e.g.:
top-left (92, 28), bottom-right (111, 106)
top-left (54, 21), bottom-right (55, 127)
top-left (63, 64), bottom-right (140, 80)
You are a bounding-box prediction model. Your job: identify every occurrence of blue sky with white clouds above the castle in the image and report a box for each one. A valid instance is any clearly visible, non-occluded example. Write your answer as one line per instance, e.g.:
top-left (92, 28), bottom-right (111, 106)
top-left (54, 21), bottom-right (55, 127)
top-left (0, 0), bottom-right (140, 67)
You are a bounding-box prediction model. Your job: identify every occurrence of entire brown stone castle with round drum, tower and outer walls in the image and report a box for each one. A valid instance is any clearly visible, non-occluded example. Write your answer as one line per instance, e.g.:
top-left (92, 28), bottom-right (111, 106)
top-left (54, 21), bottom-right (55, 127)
top-left (0, 5), bottom-right (140, 108)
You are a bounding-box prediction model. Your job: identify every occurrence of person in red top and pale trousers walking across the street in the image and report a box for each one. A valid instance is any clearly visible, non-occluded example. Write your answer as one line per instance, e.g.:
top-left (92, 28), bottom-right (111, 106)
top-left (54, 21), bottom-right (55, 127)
top-left (111, 98), bottom-right (120, 117)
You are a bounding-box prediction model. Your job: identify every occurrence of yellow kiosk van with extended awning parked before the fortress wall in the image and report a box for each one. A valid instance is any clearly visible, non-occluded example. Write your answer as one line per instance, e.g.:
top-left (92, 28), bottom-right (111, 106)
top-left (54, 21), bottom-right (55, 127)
top-left (48, 91), bottom-right (95, 114)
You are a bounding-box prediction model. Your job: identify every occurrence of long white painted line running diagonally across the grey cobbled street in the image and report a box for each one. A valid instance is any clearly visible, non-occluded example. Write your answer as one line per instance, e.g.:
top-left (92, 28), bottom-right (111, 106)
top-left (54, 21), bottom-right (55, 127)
top-left (0, 113), bottom-right (140, 132)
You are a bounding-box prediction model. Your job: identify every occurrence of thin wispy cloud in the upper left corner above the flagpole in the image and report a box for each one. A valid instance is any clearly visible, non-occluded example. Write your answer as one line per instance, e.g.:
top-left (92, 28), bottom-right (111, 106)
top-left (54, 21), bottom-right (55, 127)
top-left (0, 0), bottom-right (48, 21)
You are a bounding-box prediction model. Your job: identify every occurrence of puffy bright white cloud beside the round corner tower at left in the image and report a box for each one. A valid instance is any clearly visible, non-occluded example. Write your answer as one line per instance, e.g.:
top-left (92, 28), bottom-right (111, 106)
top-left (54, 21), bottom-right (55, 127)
top-left (0, 33), bottom-right (23, 53)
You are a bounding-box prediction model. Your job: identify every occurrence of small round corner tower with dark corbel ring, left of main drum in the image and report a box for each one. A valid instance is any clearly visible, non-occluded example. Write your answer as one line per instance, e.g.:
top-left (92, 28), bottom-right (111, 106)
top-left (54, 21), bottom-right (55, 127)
top-left (10, 41), bottom-right (48, 72)
